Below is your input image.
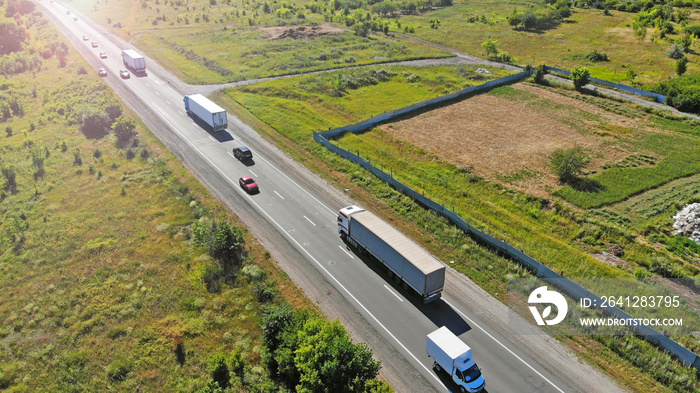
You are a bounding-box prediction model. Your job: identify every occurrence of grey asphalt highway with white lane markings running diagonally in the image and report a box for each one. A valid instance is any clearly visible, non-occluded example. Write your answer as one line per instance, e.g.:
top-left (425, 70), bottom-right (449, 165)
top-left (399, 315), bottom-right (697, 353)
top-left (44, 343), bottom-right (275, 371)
top-left (35, 0), bottom-right (623, 393)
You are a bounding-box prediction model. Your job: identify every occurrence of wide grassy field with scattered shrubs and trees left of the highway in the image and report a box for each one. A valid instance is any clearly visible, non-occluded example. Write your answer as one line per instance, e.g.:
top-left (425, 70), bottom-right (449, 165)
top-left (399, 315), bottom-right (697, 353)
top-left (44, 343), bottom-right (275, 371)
top-left (0, 6), bottom-right (391, 392)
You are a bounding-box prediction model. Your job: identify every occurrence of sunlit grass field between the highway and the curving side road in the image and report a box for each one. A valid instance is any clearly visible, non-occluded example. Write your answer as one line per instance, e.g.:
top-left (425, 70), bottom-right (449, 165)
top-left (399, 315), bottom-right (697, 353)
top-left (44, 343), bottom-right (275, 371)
top-left (72, 0), bottom-right (450, 84)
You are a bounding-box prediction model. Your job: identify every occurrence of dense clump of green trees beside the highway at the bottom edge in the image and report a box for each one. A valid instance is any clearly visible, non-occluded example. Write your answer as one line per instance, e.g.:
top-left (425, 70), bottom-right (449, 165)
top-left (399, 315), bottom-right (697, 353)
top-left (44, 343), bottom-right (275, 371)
top-left (263, 305), bottom-right (386, 393)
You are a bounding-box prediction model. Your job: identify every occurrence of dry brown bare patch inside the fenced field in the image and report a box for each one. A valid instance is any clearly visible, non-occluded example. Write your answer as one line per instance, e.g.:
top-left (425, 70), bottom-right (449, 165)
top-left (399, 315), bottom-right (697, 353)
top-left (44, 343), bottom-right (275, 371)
top-left (382, 84), bottom-right (635, 197)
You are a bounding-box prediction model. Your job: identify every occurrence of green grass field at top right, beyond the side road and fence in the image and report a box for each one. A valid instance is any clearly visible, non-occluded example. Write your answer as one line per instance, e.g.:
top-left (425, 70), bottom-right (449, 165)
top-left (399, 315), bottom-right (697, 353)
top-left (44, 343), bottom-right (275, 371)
top-left (401, 0), bottom-right (698, 84)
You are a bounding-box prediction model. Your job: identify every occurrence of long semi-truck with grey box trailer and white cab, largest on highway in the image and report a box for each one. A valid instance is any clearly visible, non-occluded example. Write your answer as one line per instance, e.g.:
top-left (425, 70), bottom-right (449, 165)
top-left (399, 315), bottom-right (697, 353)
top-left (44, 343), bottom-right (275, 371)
top-left (338, 206), bottom-right (445, 303)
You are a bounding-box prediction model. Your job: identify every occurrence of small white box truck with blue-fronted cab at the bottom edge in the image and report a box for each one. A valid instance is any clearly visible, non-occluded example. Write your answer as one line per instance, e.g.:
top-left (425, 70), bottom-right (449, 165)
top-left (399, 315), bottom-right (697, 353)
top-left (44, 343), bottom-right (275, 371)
top-left (426, 326), bottom-right (486, 393)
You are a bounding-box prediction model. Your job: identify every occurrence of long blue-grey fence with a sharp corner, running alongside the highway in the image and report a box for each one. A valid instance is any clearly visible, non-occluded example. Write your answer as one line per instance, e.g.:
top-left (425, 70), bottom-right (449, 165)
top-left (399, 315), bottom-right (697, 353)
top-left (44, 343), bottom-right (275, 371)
top-left (313, 69), bottom-right (700, 370)
